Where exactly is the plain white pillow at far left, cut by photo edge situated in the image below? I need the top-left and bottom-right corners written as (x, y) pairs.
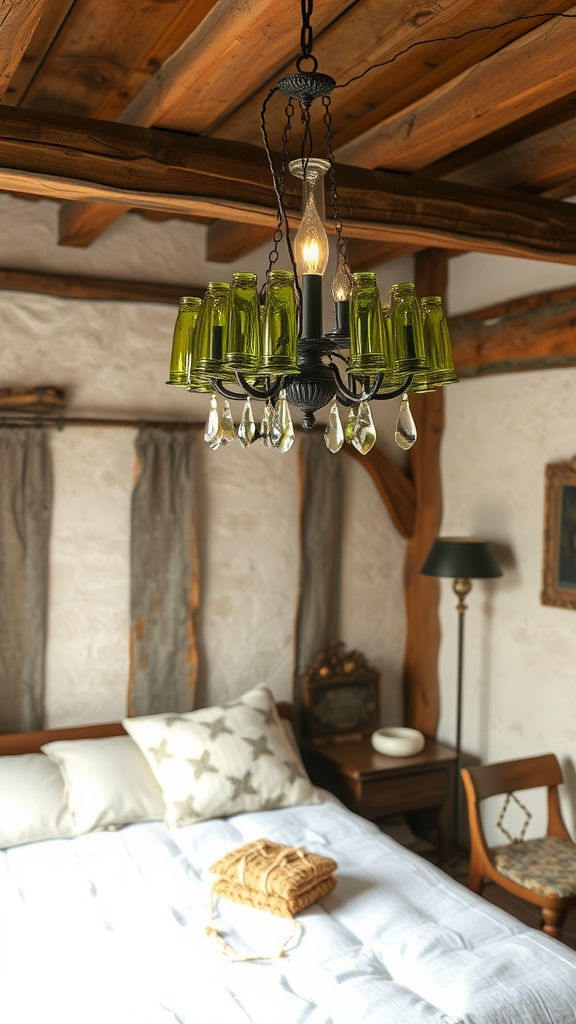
top-left (0, 754), bottom-right (72, 847)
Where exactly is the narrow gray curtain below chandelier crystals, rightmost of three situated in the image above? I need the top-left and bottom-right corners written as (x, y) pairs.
top-left (293, 427), bottom-right (344, 729)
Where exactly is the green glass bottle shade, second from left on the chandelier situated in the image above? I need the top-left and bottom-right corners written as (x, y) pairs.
top-left (191, 281), bottom-right (235, 390)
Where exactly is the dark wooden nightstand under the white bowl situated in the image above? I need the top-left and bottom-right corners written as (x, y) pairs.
top-left (301, 736), bottom-right (456, 863)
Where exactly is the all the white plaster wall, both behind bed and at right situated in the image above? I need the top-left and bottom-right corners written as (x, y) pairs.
top-left (0, 196), bottom-right (576, 843)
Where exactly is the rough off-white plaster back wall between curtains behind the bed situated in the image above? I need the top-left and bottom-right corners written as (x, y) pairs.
top-left (0, 197), bottom-right (404, 725)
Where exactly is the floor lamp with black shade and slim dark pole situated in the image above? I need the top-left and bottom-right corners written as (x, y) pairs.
top-left (420, 537), bottom-right (502, 851)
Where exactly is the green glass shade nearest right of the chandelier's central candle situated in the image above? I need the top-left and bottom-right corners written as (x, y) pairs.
top-left (349, 270), bottom-right (389, 375)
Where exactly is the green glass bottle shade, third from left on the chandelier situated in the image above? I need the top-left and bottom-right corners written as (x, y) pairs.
top-left (224, 273), bottom-right (262, 376)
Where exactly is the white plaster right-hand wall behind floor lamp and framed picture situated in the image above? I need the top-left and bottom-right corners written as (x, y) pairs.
top-left (440, 256), bottom-right (576, 840)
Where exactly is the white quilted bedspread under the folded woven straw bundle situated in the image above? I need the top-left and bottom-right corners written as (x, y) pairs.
top-left (0, 798), bottom-right (576, 1024)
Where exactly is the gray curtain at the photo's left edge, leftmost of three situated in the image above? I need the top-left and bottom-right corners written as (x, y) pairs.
top-left (0, 427), bottom-right (52, 732)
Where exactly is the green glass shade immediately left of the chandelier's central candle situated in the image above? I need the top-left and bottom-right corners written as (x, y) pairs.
top-left (261, 270), bottom-right (299, 377)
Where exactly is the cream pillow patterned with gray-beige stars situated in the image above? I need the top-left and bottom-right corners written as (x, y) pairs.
top-left (122, 686), bottom-right (322, 827)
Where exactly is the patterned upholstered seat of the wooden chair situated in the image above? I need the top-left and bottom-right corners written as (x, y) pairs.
top-left (491, 836), bottom-right (576, 898)
